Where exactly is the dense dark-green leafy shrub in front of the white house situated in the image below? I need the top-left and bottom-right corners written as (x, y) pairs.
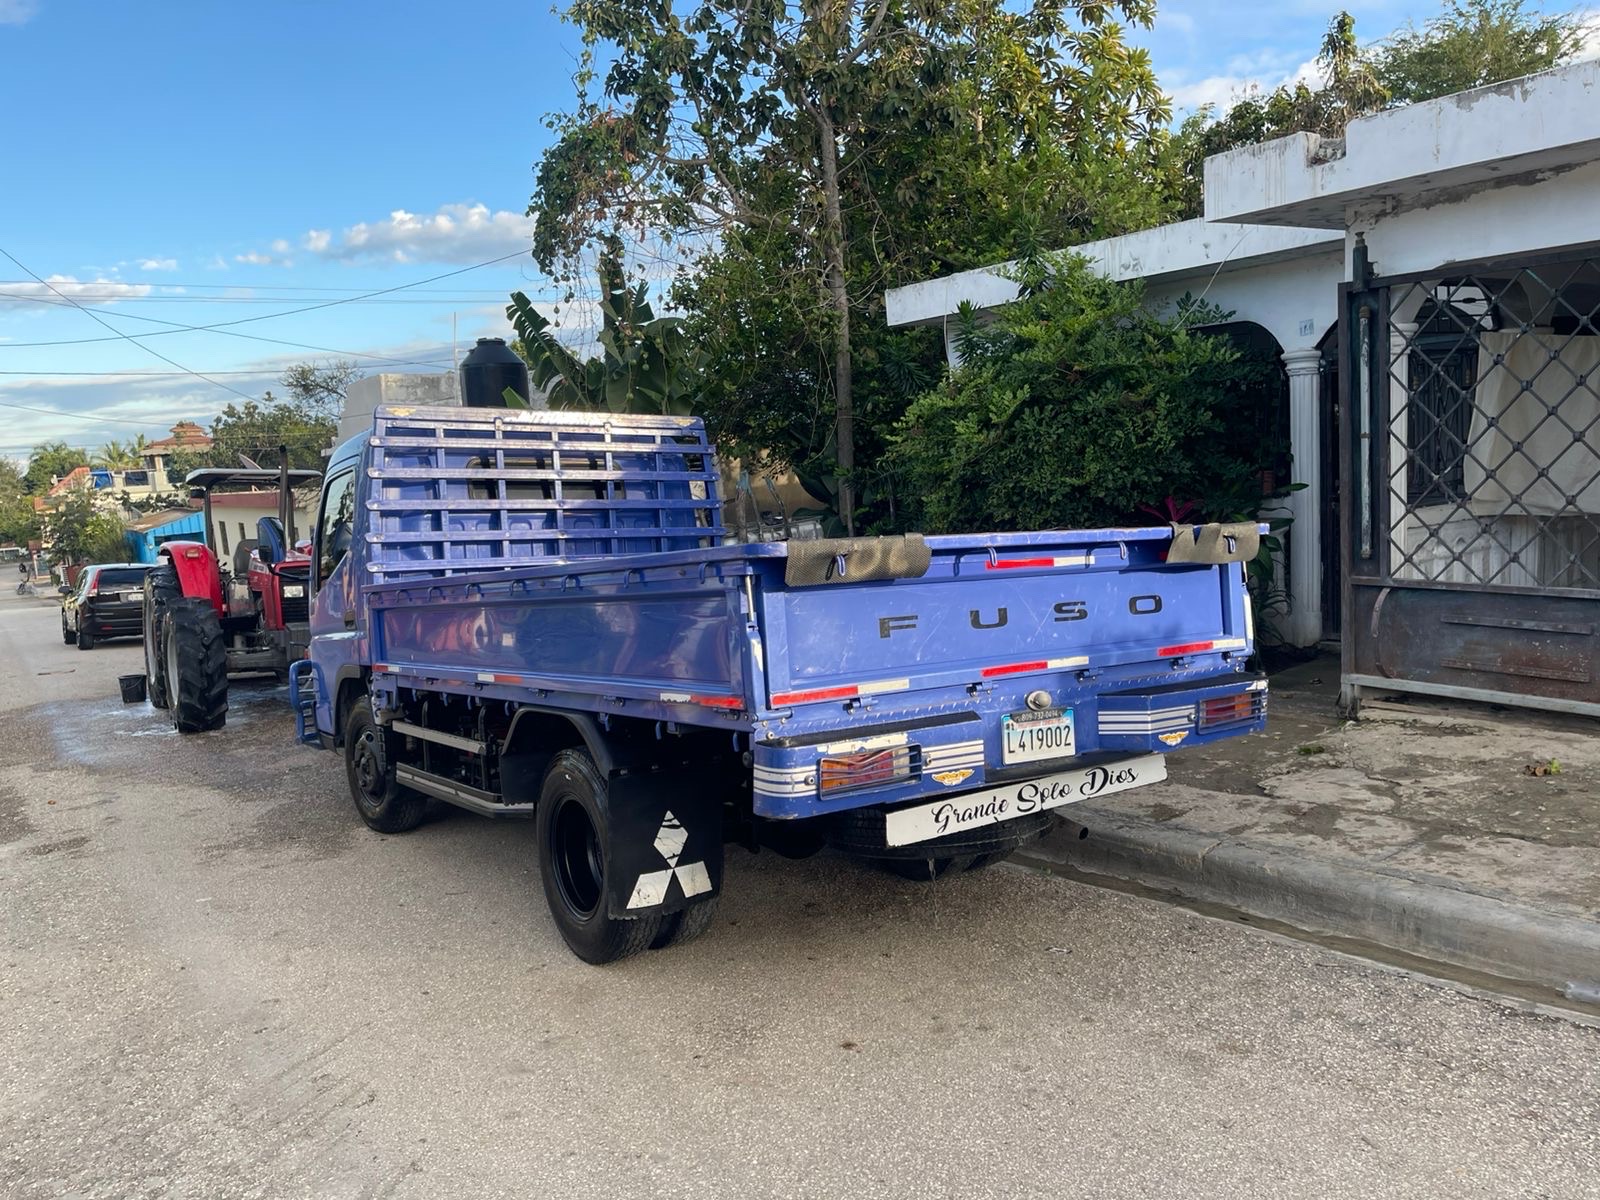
top-left (891, 258), bottom-right (1278, 533)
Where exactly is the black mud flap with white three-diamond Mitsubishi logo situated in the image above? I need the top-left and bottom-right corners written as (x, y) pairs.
top-left (606, 771), bottom-right (722, 917)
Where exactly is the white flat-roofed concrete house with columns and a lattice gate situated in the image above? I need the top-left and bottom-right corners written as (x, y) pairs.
top-left (886, 62), bottom-right (1600, 715)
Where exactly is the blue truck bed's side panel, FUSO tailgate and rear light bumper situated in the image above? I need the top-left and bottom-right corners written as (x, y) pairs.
top-left (365, 528), bottom-right (1266, 818)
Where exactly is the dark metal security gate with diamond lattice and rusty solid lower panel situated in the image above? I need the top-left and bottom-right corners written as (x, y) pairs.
top-left (1339, 246), bottom-right (1600, 717)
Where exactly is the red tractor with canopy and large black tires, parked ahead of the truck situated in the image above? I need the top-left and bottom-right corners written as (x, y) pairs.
top-left (144, 467), bottom-right (322, 733)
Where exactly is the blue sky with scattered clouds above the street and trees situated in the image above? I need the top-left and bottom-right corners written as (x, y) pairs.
top-left (0, 0), bottom-right (1574, 458)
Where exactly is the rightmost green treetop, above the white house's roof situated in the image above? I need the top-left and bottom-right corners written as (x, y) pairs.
top-left (1368, 0), bottom-right (1584, 104)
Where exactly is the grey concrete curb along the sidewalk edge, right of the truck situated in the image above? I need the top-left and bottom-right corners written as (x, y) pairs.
top-left (1011, 806), bottom-right (1600, 1005)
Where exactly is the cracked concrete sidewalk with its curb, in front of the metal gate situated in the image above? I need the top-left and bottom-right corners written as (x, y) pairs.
top-left (1013, 656), bottom-right (1600, 1008)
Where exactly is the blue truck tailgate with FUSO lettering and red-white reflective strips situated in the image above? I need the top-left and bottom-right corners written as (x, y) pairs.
top-left (760, 530), bottom-right (1250, 709)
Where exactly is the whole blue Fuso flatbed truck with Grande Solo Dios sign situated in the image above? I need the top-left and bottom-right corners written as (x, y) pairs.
top-left (291, 400), bottom-right (1267, 963)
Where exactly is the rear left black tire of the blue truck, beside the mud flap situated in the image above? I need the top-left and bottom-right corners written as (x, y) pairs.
top-left (534, 750), bottom-right (662, 966)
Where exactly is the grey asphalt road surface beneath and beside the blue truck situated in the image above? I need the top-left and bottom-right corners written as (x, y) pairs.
top-left (0, 594), bottom-right (1600, 1200)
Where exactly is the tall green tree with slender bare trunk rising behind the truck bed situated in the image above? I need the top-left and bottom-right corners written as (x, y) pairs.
top-left (530, 0), bottom-right (1168, 522)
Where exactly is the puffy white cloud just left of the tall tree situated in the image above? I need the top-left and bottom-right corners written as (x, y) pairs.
top-left (301, 205), bottom-right (533, 262)
